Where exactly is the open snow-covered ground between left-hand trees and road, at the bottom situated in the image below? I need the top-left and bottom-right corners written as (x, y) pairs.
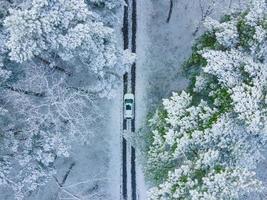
top-left (22, 96), bottom-right (120, 200)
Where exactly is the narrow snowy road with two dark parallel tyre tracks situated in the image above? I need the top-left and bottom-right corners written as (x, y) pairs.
top-left (121, 0), bottom-right (137, 200)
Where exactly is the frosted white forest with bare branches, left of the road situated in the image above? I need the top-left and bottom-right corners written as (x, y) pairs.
top-left (0, 0), bottom-right (125, 199)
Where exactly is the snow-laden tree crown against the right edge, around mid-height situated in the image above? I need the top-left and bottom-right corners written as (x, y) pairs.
top-left (202, 49), bottom-right (267, 132)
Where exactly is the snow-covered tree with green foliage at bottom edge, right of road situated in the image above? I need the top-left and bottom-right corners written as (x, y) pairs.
top-left (148, 161), bottom-right (262, 200)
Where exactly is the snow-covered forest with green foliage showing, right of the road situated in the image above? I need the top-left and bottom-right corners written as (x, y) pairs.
top-left (145, 0), bottom-right (267, 200)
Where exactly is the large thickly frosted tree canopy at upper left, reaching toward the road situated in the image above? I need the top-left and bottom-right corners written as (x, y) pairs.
top-left (5, 0), bottom-right (124, 96)
